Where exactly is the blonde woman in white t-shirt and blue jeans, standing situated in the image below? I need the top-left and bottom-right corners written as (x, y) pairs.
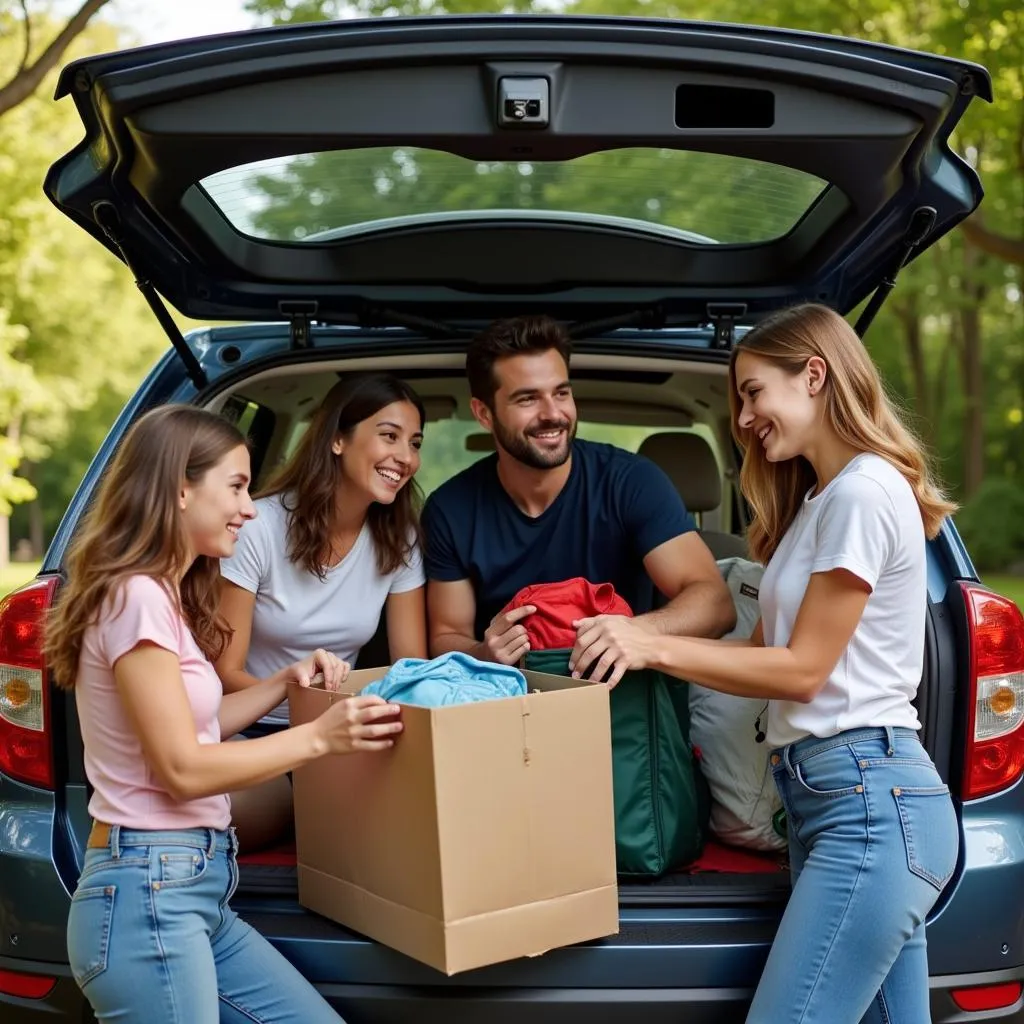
top-left (572, 304), bottom-right (959, 1024)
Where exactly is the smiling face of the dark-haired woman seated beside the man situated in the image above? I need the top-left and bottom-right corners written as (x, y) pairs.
top-left (332, 401), bottom-right (423, 505)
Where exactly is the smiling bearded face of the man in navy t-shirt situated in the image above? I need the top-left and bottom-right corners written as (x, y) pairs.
top-left (473, 348), bottom-right (577, 469)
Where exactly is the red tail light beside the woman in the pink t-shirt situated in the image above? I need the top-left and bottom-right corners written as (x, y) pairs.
top-left (0, 577), bottom-right (57, 790)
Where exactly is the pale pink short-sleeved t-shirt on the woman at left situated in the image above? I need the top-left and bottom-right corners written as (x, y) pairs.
top-left (75, 575), bottom-right (231, 828)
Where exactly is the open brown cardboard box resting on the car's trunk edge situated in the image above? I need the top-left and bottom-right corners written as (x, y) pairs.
top-left (290, 669), bottom-right (618, 975)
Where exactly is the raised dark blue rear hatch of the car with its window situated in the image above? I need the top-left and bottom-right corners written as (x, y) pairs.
top-left (45, 15), bottom-right (991, 360)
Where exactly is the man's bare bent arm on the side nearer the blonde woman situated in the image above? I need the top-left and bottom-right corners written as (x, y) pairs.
top-left (637, 530), bottom-right (736, 637)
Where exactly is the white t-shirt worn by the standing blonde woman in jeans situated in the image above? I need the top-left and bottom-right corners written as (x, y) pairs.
top-left (759, 454), bottom-right (928, 746)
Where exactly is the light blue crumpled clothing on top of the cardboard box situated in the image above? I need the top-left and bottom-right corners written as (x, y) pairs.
top-left (362, 650), bottom-right (526, 708)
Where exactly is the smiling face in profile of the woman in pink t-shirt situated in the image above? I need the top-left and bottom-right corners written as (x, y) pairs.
top-left (178, 444), bottom-right (256, 558)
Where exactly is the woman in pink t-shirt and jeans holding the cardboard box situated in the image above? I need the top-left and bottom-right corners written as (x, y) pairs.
top-left (46, 406), bottom-right (401, 1024)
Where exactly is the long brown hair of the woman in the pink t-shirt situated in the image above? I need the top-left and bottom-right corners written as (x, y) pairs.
top-left (45, 406), bottom-right (246, 689)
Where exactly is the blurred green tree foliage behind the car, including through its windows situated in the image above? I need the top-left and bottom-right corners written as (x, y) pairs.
top-left (0, 0), bottom-right (1024, 567)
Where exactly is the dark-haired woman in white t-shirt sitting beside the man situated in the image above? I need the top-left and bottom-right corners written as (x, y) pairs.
top-left (217, 373), bottom-right (427, 849)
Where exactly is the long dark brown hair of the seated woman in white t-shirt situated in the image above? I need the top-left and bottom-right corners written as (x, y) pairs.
top-left (257, 373), bottom-right (426, 580)
